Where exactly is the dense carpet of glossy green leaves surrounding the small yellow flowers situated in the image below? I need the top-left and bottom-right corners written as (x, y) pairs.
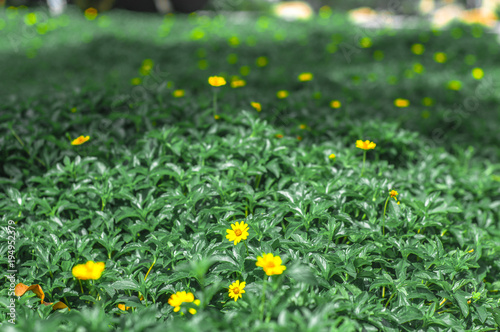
top-left (0, 5), bottom-right (500, 331)
